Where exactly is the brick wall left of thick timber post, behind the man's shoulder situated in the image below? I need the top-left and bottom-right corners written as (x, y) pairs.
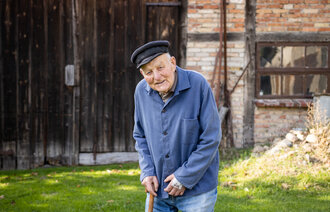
top-left (186, 0), bottom-right (245, 147)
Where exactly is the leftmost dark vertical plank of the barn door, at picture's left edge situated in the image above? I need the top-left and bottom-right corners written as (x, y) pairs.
top-left (0, 0), bottom-right (17, 169)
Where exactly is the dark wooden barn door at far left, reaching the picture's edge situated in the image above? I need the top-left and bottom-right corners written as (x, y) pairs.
top-left (0, 0), bottom-right (73, 169)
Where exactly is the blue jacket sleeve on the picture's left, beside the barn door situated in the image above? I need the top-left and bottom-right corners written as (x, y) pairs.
top-left (133, 94), bottom-right (156, 182)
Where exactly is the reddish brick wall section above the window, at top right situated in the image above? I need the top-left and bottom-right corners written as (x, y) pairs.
top-left (256, 0), bottom-right (330, 32)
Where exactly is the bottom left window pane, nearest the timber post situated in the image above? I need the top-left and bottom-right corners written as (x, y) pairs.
top-left (259, 75), bottom-right (281, 96)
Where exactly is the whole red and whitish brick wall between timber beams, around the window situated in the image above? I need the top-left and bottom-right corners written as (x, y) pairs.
top-left (186, 0), bottom-right (330, 147)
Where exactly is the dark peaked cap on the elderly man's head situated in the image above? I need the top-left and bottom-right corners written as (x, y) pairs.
top-left (131, 40), bottom-right (170, 68)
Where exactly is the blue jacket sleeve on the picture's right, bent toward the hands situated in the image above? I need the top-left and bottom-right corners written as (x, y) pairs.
top-left (174, 85), bottom-right (221, 189)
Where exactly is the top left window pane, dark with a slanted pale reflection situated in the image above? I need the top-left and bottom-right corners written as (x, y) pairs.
top-left (260, 46), bottom-right (281, 68)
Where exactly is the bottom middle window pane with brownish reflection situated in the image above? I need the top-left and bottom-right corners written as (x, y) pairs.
top-left (282, 75), bottom-right (303, 96)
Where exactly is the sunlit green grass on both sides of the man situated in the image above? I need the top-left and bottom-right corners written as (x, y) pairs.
top-left (0, 151), bottom-right (330, 212)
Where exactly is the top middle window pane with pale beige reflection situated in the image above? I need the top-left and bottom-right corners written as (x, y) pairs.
top-left (283, 46), bottom-right (305, 67)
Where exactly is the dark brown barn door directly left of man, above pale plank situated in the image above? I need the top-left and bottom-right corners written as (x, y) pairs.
top-left (77, 0), bottom-right (143, 157)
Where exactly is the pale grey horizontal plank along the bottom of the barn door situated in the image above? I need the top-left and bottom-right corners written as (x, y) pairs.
top-left (79, 152), bottom-right (139, 165)
